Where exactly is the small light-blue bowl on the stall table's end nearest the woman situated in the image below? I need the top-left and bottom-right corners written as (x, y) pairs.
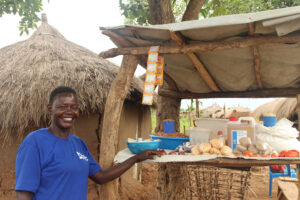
top-left (126, 140), bottom-right (160, 154)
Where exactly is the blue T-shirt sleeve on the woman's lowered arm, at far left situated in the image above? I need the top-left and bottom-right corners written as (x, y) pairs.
top-left (15, 142), bottom-right (41, 193)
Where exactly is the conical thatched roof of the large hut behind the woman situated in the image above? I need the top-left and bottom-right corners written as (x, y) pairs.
top-left (0, 15), bottom-right (143, 139)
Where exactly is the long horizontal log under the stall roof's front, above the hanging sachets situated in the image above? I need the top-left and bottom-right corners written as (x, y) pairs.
top-left (99, 34), bottom-right (300, 58)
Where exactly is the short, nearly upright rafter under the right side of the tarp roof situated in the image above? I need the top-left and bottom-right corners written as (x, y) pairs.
top-left (248, 22), bottom-right (263, 89)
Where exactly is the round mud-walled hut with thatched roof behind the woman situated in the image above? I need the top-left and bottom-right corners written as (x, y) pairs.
top-left (0, 16), bottom-right (151, 200)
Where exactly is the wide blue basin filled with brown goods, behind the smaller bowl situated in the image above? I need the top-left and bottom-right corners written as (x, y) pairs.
top-left (149, 135), bottom-right (190, 150)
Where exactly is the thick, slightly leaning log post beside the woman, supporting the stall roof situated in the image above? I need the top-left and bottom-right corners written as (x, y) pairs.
top-left (100, 56), bottom-right (138, 200)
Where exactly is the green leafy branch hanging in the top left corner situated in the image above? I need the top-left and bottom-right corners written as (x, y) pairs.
top-left (0, 0), bottom-right (43, 35)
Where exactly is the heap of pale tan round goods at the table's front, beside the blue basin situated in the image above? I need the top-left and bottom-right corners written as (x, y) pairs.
top-left (191, 139), bottom-right (234, 156)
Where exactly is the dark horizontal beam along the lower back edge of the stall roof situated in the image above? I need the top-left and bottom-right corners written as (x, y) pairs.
top-left (158, 88), bottom-right (300, 99)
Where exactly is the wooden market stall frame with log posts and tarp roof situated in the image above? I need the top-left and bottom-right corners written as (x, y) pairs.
top-left (100, 7), bottom-right (300, 199)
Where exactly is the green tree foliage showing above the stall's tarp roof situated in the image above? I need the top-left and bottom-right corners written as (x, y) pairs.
top-left (119, 0), bottom-right (300, 25)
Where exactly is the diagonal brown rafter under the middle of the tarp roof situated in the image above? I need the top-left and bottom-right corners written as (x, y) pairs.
top-left (169, 31), bottom-right (220, 92)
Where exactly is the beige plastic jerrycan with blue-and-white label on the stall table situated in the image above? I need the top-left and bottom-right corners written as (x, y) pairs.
top-left (227, 117), bottom-right (255, 149)
